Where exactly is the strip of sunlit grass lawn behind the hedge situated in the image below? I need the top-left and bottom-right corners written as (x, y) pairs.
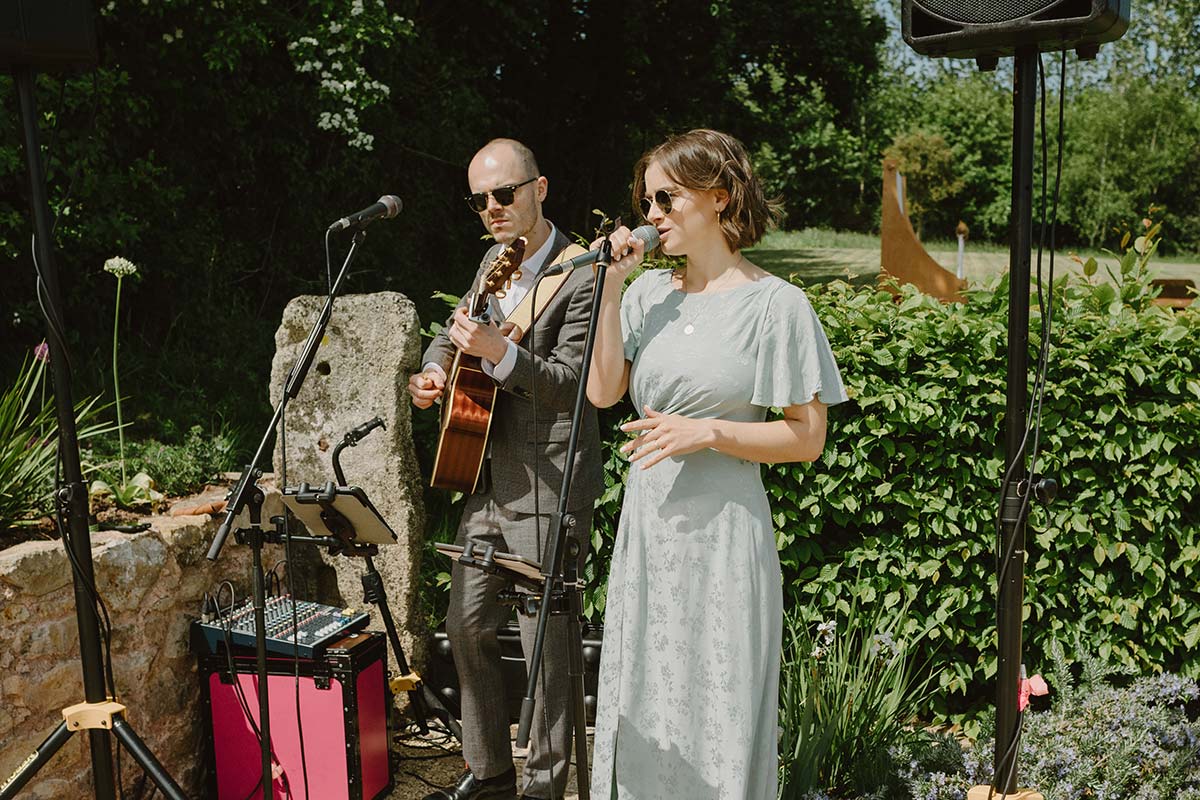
top-left (746, 228), bottom-right (1200, 291)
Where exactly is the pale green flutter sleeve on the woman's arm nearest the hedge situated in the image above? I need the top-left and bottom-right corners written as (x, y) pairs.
top-left (748, 283), bottom-right (848, 408)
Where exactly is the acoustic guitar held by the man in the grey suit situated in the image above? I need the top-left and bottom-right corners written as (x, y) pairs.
top-left (430, 237), bottom-right (526, 492)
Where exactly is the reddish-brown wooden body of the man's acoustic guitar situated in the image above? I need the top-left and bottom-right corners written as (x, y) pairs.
top-left (430, 353), bottom-right (496, 493)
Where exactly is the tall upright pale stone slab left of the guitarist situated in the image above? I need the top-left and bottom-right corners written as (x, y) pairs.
top-left (271, 291), bottom-right (425, 667)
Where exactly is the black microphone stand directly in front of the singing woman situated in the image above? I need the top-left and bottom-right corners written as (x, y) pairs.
top-left (517, 239), bottom-right (612, 800)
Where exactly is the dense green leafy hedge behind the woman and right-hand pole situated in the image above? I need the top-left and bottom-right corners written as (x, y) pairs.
top-left (588, 244), bottom-right (1200, 714)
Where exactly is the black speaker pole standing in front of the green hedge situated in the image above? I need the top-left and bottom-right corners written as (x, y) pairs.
top-left (992, 47), bottom-right (1038, 795)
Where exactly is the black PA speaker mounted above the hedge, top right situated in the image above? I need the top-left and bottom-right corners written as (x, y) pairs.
top-left (900, 0), bottom-right (1129, 60)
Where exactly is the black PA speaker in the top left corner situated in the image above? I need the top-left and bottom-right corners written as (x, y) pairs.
top-left (0, 0), bottom-right (97, 68)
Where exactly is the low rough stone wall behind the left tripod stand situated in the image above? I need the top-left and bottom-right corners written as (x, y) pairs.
top-left (0, 503), bottom-right (282, 800)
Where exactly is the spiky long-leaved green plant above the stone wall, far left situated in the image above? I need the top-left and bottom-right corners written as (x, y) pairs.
top-left (0, 357), bottom-right (114, 531)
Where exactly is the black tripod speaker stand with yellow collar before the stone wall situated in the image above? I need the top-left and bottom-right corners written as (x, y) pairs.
top-left (0, 67), bottom-right (185, 800)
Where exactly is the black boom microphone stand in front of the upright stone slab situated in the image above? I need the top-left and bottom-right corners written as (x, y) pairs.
top-left (206, 228), bottom-right (366, 799)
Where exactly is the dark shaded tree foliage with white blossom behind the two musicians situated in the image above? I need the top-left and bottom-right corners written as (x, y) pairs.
top-left (0, 0), bottom-right (883, 434)
